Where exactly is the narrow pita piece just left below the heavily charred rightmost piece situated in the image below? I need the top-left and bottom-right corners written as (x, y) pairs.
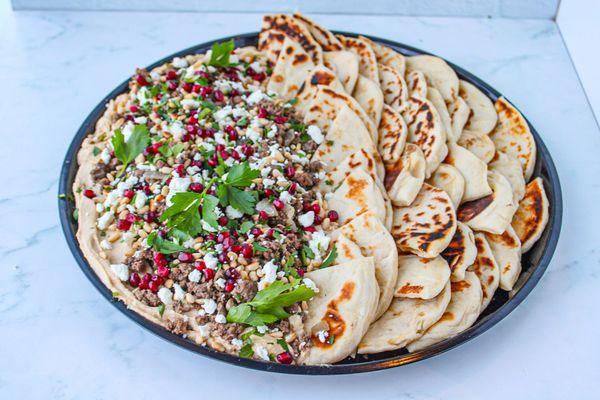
top-left (485, 225), bottom-right (521, 291)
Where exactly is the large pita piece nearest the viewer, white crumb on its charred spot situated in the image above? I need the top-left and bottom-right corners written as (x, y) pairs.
top-left (299, 257), bottom-right (379, 365)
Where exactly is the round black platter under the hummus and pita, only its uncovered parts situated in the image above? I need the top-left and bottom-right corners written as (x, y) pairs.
top-left (59, 32), bottom-right (562, 375)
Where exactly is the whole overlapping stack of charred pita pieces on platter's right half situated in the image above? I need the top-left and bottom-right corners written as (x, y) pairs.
top-left (259, 14), bottom-right (549, 364)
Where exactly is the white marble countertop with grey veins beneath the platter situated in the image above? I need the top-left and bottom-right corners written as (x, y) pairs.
top-left (0, 7), bottom-right (600, 400)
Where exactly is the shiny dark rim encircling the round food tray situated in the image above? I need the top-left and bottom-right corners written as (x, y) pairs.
top-left (58, 31), bottom-right (563, 375)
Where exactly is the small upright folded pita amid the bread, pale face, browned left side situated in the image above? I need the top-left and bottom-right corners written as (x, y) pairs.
top-left (384, 143), bottom-right (426, 207)
